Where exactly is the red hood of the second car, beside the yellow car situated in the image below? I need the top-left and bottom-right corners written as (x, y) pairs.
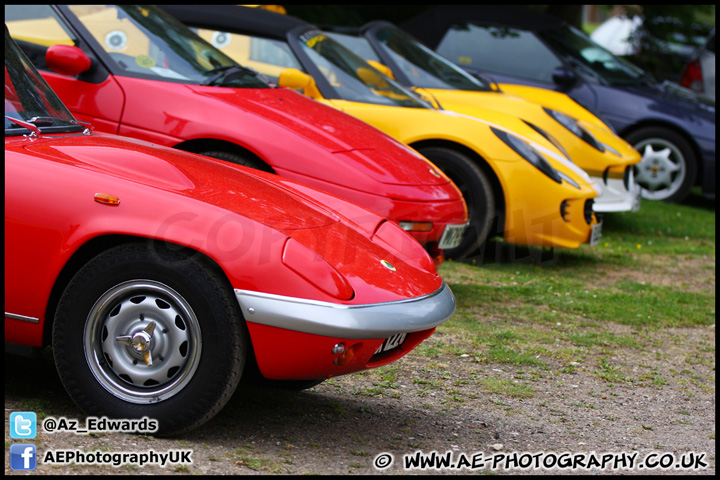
top-left (187, 85), bottom-right (449, 185)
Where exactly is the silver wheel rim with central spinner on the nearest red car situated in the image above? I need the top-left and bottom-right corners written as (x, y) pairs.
top-left (83, 280), bottom-right (202, 404)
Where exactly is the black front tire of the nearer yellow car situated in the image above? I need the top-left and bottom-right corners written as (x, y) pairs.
top-left (419, 147), bottom-right (495, 260)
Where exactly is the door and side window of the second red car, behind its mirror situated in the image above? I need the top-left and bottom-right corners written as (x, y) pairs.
top-left (5, 5), bottom-right (125, 133)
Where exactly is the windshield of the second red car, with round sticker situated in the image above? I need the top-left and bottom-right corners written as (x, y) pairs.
top-left (62, 5), bottom-right (268, 88)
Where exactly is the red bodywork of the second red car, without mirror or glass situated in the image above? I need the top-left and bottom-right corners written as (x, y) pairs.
top-left (43, 67), bottom-right (466, 249)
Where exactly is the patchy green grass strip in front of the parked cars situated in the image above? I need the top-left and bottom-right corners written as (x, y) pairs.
top-left (428, 191), bottom-right (715, 390)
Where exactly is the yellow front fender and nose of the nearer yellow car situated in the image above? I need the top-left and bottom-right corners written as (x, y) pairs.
top-left (320, 99), bottom-right (597, 248)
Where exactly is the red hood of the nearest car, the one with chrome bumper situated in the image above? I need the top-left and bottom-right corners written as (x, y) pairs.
top-left (15, 134), bottom-right (340, 231)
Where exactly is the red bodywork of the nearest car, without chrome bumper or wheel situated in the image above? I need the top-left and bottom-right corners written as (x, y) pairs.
top-left (5, 134), bottom-right (442, 378)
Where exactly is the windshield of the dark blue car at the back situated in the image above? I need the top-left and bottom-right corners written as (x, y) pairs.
top-left (540, 27), bottom-right (646, 85)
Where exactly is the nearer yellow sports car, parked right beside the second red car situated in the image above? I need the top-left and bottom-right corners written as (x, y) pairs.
top-left (166, 5), bottom-right (601, 258)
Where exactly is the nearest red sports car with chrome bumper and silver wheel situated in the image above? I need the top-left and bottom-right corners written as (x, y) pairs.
top-left (5, 29), bottom-right (455, 434)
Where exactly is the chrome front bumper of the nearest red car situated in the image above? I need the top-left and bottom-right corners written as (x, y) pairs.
top-left (235, 282), bottom-right (455, 339)
